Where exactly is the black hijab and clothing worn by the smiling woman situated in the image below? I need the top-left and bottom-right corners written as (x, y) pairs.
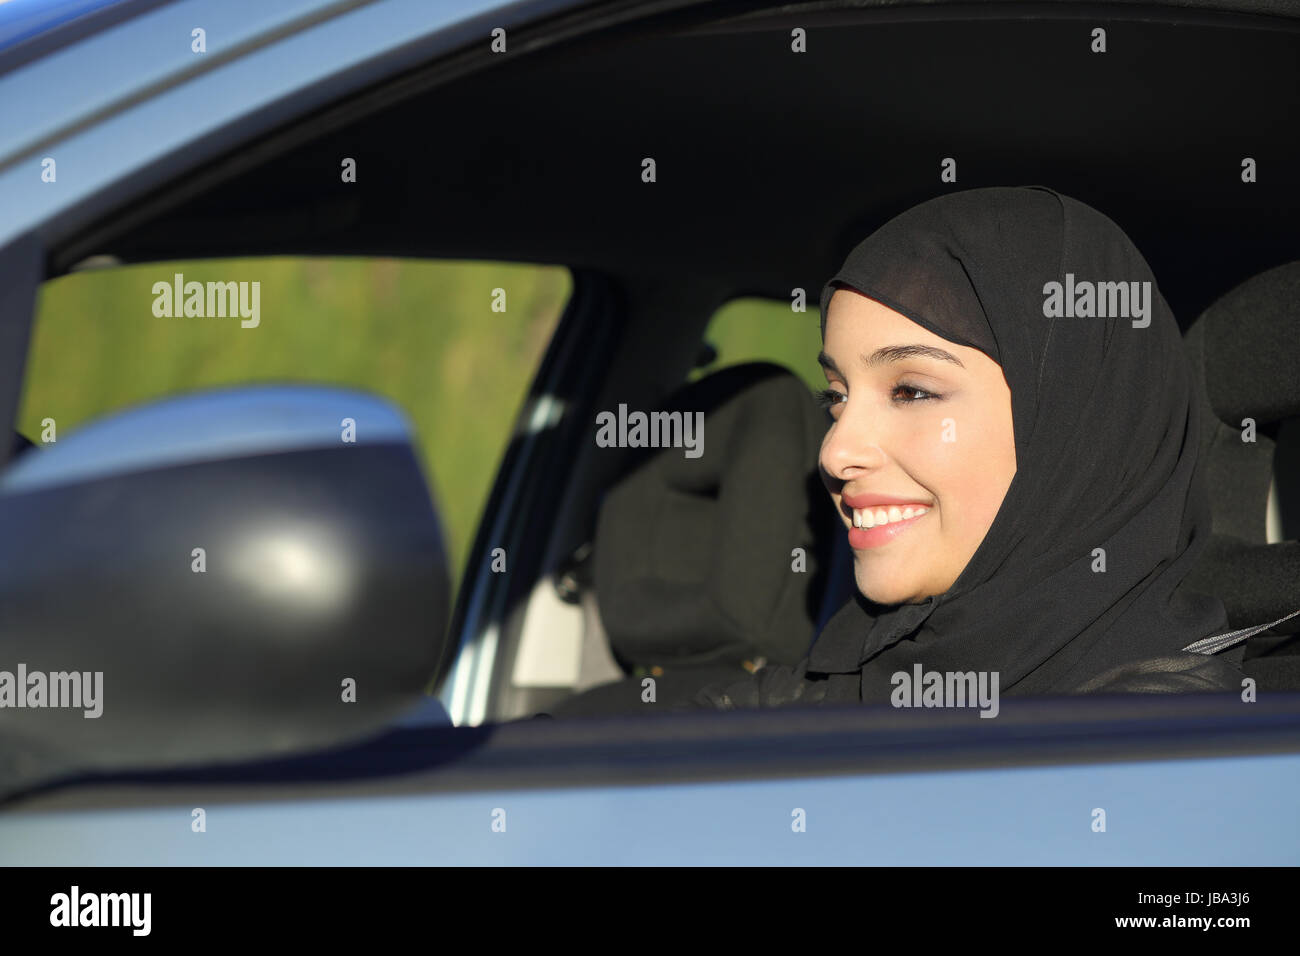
top-left (696, 186), bottom-right (1242, 708)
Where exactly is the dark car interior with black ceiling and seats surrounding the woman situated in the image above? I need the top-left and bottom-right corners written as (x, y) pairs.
top-left (12, 4), bottom-right (1300, 724)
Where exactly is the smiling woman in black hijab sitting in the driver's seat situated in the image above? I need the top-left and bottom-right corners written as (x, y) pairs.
top-left (694, 186), bottom-right (1242, 709)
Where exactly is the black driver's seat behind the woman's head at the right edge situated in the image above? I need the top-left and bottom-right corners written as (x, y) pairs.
top-left (1185, 261), bottom-right (1300, 689)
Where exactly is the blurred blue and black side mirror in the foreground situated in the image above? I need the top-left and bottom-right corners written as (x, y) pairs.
top-left (0, 386), bottom-right (450, 792)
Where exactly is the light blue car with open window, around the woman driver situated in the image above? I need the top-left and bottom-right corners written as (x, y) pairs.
top-left (0, 0), bottom-right (1300, 874)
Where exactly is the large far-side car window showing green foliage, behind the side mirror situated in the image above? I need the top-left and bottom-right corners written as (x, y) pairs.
top-left (18, 258), bottom-right (571, 595)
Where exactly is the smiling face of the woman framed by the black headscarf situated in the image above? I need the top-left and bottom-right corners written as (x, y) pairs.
top-left (820, 289), bottom-right (1015, 604)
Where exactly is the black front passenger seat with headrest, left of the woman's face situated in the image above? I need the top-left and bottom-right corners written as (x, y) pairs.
top-left (593, 363), bottom-right (833, 670)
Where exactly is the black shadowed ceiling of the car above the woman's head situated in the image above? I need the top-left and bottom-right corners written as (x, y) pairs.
top-left (55, 4), bottom-right (1300, 328)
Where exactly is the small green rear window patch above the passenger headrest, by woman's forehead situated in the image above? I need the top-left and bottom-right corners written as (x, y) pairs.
top-left (692, 297), bottom-right (826, 389)
